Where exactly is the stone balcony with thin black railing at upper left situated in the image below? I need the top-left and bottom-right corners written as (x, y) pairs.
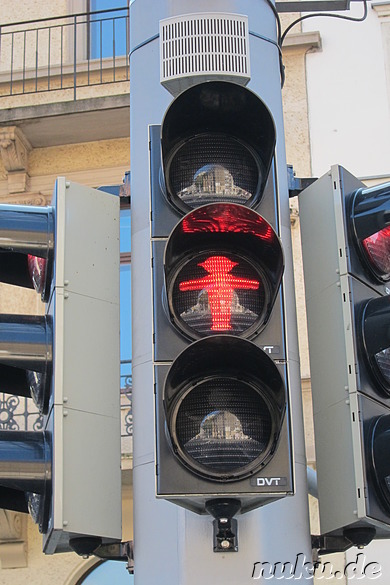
top-left (0, 8), bottom-right (130, 148)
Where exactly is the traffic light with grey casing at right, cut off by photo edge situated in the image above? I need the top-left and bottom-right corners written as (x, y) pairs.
top-left (299, 166), bottom-right (390, 546)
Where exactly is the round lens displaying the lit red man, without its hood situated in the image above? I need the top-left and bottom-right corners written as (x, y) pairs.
top-left (170, 253), bottom-right (267, 336)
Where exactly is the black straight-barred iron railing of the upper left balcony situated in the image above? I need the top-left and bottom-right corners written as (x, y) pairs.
top-left (0, 7), bottom-right (129, 99)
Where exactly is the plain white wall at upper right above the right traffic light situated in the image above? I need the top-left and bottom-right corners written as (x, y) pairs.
top-left (302, 2), bottom-right (390, 177)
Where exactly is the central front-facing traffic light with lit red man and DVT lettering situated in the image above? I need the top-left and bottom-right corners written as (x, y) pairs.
top-left (150, 81), bottom-right (294, 513)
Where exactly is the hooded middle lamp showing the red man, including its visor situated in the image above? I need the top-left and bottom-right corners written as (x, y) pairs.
top-left (164, 203), bottom-right (284, 339)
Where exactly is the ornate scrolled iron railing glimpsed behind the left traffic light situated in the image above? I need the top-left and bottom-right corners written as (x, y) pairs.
top-left (0, 360), bottom-right (133, 438)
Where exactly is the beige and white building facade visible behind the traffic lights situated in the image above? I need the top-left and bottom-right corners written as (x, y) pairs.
top-left (0, 0), bottom-right (390, 585)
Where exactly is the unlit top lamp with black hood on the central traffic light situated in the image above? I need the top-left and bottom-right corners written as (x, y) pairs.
top-left (161, 81), bottom-right (276, 213)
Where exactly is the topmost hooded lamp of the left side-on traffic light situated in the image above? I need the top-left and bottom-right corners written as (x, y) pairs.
top-left (0, 205), bottom-right (54, 302)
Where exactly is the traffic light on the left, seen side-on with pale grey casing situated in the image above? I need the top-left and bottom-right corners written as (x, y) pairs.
top-left (0, 177), bottom-right (121, 554)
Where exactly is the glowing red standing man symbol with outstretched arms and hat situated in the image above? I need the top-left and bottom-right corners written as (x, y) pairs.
top-left (179, 256), bottom-right (260, 331)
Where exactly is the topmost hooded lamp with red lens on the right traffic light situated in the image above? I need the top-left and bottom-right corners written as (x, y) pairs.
top-left (351, 183), bottom-right (390, 282)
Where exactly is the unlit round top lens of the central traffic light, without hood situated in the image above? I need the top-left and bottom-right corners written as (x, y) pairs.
top-left (169, 134), bottom-right (262, 209)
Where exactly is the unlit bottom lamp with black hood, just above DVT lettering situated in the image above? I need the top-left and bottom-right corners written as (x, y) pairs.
top-left (163, 336), bottom-right (286, 482)
